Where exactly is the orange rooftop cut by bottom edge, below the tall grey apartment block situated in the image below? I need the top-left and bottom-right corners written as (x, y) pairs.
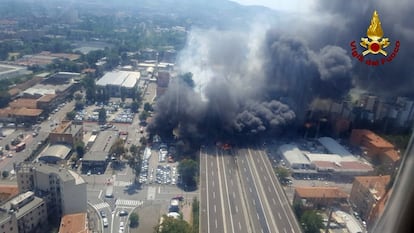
top-left (59, 213), bottom-right (90, 233)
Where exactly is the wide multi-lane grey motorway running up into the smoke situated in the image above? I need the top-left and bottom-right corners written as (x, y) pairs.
top-left (200, 147), bottom-right (301, 233)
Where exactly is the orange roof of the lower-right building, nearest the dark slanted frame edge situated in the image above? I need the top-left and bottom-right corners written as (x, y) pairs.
top-left (354, 175), bottom-right (391, 201)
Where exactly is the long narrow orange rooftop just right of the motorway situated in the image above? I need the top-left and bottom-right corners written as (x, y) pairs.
top-left (295, 187), bottom-right (348, 198)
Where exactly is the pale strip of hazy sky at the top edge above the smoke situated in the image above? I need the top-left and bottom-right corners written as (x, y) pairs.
top-left (232, 0), bottom-right (315, 12)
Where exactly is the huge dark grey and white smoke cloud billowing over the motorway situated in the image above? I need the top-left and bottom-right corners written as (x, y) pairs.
top-left (150, 0), bottom-right (414, 142)
